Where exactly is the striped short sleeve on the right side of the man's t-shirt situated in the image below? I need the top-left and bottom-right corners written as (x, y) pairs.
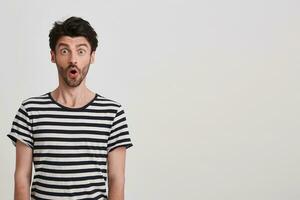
top-left (107, 105), bottom-right (133, 153)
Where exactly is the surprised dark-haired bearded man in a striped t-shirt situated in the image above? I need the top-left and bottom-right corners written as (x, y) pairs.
top-left (7, 17), bottom-right (133, 200)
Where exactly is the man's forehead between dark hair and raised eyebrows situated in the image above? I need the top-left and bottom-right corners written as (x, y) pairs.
top-left (56, 36), bottom-right (91, 48)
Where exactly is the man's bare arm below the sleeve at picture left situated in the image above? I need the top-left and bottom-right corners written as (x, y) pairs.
top-left (14, 141), bottom-right (32, 200)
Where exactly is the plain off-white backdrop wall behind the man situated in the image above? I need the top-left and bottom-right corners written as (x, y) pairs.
top-left (0, 0), bottom-right (300, 200)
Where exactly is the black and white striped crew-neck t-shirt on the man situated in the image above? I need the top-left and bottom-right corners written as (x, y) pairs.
top-left (7, 92), bottom-right (133, 200)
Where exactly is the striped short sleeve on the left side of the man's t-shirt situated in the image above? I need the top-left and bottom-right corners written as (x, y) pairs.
top-left (7, 103), bottom-right (33, 148)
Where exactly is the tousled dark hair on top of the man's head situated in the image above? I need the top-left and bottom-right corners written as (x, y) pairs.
top-left (49, 17), bottom-right (98, 53)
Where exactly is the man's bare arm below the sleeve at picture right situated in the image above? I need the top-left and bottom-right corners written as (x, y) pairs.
top-left (108, 147), bottom-right (126, 200)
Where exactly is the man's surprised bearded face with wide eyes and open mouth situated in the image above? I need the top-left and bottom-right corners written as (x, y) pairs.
top-left (51, 36), bottom-right (95, 87)
